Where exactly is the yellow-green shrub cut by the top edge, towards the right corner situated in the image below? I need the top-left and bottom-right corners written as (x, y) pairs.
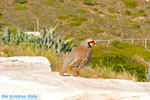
top-left (122, 0), bottom-right (139, 8)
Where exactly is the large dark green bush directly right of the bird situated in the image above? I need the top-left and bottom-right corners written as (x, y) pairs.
top-left (90, 52), bottom-right (147, 81)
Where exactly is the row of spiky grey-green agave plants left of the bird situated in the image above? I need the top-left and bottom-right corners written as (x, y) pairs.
top-left (0, 24), bottom-right (73, 53)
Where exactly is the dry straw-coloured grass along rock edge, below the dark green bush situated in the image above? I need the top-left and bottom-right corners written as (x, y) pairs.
top-left (81, 66), bottom-right (137, 81)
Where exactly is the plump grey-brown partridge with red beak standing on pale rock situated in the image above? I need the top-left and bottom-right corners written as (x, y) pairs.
top-left (59, 39), bottom-right (96, 77)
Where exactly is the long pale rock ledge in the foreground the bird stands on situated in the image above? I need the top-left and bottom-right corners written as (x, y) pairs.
top-left (0, 71), bottom-right (150, 100)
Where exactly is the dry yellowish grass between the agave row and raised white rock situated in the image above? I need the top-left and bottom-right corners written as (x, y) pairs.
top-left (0, 44), bottom-right (64, 71)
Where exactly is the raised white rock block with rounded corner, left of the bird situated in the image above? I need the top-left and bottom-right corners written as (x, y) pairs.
top-left (0, 56), bottom-right (51, 72)
